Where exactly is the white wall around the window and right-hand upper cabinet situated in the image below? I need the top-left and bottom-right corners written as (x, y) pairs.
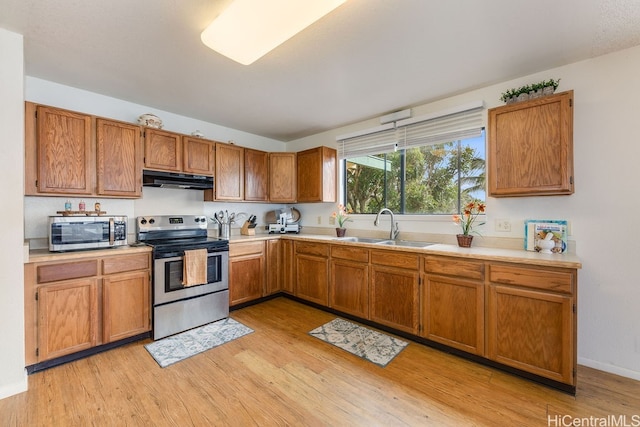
top-left (289, 47), bottom-right (640, 379)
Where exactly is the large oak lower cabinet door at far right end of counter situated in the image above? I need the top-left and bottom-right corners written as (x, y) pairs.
top-left (487, 284), bottom-right (575, 385)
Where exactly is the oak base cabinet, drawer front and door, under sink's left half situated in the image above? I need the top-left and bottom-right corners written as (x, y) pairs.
top-left (329, 245), bottom-right (369, 319)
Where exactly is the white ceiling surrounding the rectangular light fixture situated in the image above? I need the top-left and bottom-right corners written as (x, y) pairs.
top-left (0, 0), bottom-right (640, 141)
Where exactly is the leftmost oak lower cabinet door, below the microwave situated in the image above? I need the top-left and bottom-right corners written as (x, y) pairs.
top-left (38, 279), bottom-right (98, 361)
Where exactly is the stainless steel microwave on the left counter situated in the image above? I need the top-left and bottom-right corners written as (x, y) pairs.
top-left (49, 216), bottom-right (127, 252)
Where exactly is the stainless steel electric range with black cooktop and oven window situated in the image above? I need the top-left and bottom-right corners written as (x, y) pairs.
top-left (136, 215), bottom-right (229, 339)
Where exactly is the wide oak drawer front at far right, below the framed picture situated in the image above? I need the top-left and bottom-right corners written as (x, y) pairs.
top-left (489, 264), bottom-right (574, 294)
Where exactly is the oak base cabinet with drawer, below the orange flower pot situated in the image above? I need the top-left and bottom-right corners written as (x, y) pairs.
top-left (420, 256), bottom-right (484, 356)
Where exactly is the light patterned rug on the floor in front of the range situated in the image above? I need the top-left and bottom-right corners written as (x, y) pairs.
top-left (145, 317), bottom-right (253, 368)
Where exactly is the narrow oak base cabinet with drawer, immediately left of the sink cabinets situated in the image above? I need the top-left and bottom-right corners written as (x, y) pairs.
top-left (294, 242), bottom-right (329, 307)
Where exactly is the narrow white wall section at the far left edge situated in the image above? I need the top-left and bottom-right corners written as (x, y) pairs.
top-left (0, 28), bottom-right (27, 399)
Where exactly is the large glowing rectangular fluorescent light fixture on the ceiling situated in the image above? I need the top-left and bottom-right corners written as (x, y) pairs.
top-left (200, 0), bottom-right (346, 65)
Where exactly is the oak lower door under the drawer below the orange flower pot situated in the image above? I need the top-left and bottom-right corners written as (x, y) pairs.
top-left (421, 275), bottom-right (484, 356)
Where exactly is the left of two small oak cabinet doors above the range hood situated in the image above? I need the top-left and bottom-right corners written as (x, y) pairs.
top-left (144, 128), bottom-right (182, 172)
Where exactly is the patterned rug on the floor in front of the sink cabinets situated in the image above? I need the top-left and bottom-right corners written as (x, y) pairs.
top-left (309, 319), bottom-right (408, 367)
